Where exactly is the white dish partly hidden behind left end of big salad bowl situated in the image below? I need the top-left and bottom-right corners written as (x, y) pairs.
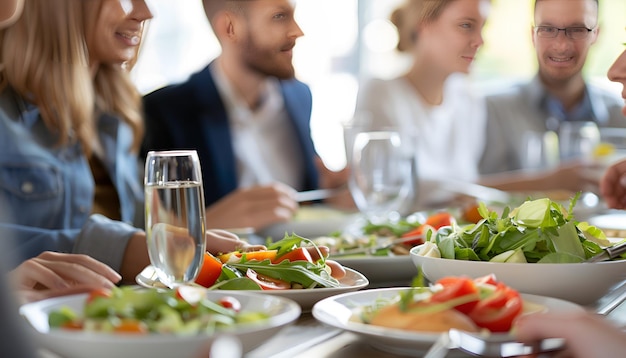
top-left (330, 254), bottom-right (417, 286)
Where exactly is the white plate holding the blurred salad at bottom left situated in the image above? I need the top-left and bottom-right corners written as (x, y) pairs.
top-left (20, 291), bottom-right (301, 358)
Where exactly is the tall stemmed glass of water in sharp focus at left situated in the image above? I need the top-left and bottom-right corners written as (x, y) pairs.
top-left (144, 150), bottom-right (206, 287)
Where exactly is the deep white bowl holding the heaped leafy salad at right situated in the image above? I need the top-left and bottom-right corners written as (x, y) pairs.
top-left (411, 246), bottom-right (626, 305)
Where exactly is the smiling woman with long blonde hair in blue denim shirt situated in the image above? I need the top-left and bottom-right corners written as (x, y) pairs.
top-left (0, 0), bottom-right (260, 288)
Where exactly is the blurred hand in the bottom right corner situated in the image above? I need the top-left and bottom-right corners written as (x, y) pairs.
top-left (513, 312), bottom-right (626, 358)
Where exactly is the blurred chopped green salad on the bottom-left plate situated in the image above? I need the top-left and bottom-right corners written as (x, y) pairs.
top-left (48, 286), bottom-right (269, 335)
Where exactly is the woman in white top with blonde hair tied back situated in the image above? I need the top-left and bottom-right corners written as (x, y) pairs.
top-left (355, 0), bottom-right (490, 205)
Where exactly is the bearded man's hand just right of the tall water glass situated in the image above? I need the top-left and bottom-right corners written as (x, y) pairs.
top-left (206, 183), bottom-right (299, 231)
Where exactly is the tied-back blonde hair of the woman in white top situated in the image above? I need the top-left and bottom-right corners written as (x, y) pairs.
top-left (389, 0), bottom-right (456, 52)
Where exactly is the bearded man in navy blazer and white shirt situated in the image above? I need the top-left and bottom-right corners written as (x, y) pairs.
top-left (143, 0), bottom-right (347, 234)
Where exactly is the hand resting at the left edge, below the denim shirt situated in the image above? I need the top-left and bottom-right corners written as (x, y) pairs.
top-left (9, 251), bottom-right (122, 302)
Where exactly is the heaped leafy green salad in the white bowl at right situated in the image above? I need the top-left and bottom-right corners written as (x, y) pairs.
top-left (418, 194), bottom-right (613, 263)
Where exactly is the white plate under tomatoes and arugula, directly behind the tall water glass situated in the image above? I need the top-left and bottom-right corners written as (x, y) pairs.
top-left (136, 266), bottom-right (369, 311)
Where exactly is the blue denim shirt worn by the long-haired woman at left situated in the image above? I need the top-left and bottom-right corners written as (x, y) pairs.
top-left (0, 89), bottom-right (143, 270)
